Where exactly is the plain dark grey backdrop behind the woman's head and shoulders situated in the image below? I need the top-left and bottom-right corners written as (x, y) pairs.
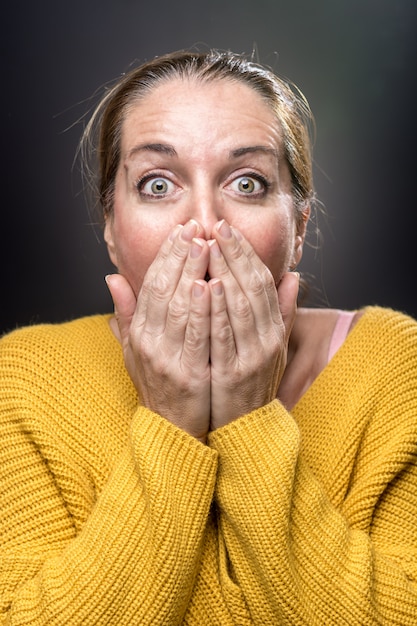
top-left (0, 0), bottom-right (417, 332)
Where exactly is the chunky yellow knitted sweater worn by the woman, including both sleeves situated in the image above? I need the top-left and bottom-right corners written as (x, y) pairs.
top-left (0, 308), bottom-right (417, 626)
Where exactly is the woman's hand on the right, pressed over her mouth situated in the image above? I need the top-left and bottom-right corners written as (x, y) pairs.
top-left (209, 222), bottom-right (299, 430)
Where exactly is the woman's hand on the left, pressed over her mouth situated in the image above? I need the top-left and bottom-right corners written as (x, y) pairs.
top-left (107, 220), bottom-right (210, 442)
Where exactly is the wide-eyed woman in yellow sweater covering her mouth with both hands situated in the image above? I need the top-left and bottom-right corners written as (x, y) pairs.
top-left (0, 52), bottom-right (417, 626)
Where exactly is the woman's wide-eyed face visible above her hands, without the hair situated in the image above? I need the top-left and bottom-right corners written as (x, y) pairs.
top-left (105, 79), bottom-right (305, 294)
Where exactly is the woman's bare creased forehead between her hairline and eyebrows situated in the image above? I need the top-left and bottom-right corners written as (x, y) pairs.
top-left (122, 78), bottom-right (282, 158)
